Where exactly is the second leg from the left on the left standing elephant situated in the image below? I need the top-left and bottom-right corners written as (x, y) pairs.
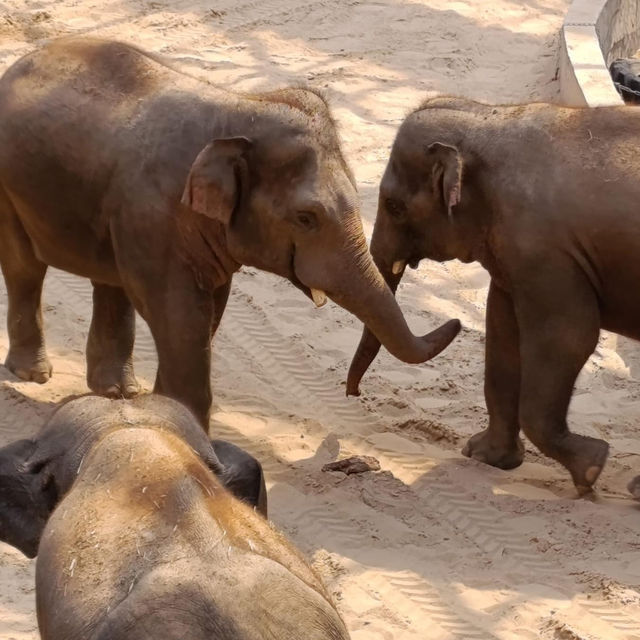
top-left (87, 282), bottom-right (140, 398)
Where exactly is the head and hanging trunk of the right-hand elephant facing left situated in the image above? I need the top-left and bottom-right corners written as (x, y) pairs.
top-left (347, 104), bottom-right (485, 395)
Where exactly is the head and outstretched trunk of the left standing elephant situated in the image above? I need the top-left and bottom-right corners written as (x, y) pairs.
top-left (182, 89), bottom-right (460, 372)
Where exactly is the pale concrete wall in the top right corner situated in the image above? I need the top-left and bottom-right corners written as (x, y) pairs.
top-left (559, 0), bottom-right (640, 107)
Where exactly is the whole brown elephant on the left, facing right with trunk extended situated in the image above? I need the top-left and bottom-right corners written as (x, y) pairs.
top-left (0, 38), bottom-right (459, 425)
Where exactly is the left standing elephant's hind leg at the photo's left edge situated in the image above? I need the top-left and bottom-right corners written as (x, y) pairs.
top-left (0, 189), bottom-right (52, 384)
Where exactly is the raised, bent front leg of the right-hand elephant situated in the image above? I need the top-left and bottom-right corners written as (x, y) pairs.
top-left (515, 263), bottom-right (609, 494)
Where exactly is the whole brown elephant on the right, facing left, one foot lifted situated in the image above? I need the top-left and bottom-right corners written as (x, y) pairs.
top-left (347, 98), bottom-right (640, 493)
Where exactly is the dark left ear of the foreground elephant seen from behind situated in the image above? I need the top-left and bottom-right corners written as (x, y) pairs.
top-left (0, 440), bottom-right (58, 558)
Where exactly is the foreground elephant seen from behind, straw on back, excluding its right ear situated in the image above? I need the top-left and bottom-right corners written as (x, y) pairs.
top-left (0, 396), bottom-right (349, 640)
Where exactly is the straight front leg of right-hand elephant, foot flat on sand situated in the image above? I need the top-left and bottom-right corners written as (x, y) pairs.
top-left (462, 282), bottom-right (524, 469)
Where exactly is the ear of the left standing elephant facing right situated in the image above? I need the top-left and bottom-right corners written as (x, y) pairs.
top-left (181, 137), bottom-right (252, 225)
